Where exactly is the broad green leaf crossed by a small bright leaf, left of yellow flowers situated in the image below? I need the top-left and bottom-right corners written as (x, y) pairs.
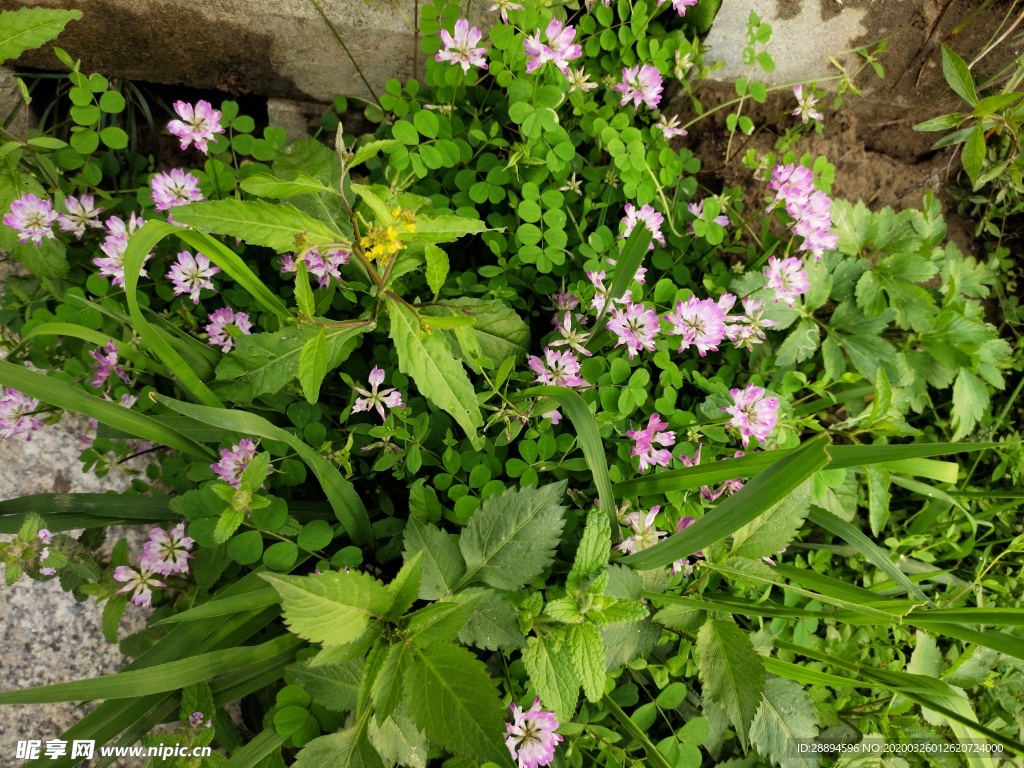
top-left (217, 321), bottom-right (374, 402)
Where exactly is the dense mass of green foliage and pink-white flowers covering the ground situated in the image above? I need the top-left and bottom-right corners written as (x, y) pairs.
top-left (0, 0), bottom-right (1024, 768)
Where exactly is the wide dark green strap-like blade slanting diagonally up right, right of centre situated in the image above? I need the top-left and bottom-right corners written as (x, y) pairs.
top-left (621, 434), bottom-right (828, 570)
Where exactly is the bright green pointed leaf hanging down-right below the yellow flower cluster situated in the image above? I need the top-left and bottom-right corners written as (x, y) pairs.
top-left (388, 300), bottom-right (483, 440)
